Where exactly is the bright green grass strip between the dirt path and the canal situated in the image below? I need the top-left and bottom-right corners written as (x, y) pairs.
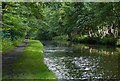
top-left (3, 40), bottom-right (57, 79)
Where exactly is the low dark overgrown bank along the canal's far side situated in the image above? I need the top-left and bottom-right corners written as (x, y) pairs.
top-left (52, 35), bottom-right (120, 47)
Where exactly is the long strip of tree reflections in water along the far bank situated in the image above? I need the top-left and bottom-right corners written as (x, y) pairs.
top-left (54, 42), bottom-right (119, 55)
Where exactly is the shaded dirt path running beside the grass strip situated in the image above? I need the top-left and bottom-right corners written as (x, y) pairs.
top-left (2, 41), bottom-right (29, 76)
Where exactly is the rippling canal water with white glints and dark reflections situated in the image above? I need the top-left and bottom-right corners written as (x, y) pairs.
top-left (43, 41), bottom-right (120, 80)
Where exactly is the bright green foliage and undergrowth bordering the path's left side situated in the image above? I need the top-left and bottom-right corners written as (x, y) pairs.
top-left (0, 2), bottom-right (43, 52)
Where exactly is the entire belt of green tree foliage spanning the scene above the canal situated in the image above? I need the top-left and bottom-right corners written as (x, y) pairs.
top-left (0, 2), bottom-right (120, 48)
